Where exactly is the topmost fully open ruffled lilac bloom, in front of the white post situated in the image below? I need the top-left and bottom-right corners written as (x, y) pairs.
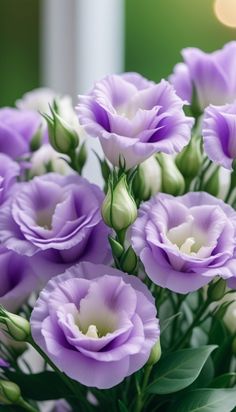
top-left (77, 73), bottom-right (193, 169)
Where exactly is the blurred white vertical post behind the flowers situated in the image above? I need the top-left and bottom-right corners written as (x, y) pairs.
top-left (41, 0), bottom-right (124, 183)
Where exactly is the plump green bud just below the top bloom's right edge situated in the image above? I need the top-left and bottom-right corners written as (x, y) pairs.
top-left (175, 136), bottom-right (202, 179)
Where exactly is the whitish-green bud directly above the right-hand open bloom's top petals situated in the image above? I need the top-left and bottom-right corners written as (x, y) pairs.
top-left (157, 153), bottom-right (185, 196)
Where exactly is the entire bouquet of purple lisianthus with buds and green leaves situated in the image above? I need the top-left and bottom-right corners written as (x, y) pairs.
top-left (0, 42), bottom-right (236, 412)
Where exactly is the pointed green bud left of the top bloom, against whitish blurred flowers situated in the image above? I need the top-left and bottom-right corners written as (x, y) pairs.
top-left (43, 108), bottom-right (79, 154)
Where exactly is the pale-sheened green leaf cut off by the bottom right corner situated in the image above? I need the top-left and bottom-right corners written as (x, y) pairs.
top-left (169, 389), bottom-right (236, 412)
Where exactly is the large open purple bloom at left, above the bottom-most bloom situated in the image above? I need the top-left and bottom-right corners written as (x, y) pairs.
top-left (0, 173), bottom-right (109, 278)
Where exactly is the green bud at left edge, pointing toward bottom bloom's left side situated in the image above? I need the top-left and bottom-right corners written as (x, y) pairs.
top-left (0, 308), bottom-right (30, 342)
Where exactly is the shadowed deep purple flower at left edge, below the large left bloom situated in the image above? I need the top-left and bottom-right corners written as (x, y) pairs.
top-left (0, 246), bottom-right (37, 312)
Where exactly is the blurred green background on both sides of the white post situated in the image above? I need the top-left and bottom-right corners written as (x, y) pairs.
top-left (0, 0), bottom-right (236, 106)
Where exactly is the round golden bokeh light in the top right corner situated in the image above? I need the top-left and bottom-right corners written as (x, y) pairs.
top-left (214, 0), bottom-right (236, 28)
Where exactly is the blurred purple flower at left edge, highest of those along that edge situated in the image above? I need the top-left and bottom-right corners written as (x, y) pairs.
top-left (0, 108), bottom-right (42, 159)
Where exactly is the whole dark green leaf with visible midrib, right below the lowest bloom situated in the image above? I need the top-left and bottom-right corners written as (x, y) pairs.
top-left (147, 345), bottom-right (216, 395)
